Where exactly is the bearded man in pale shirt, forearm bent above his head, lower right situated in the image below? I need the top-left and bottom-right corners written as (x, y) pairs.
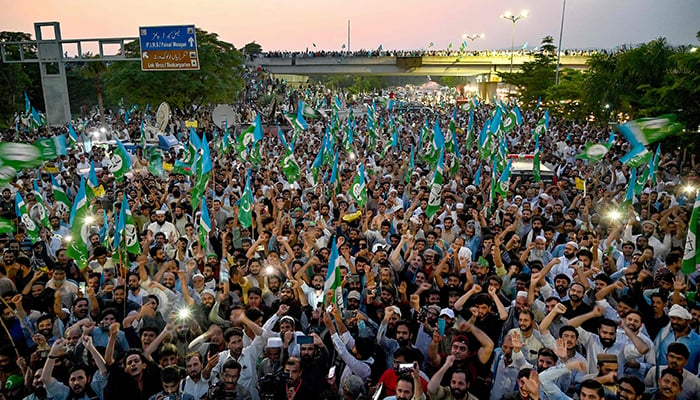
top-left (569, 306), bottom-right (649, 376)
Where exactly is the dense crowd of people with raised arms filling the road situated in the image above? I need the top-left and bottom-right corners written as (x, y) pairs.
top-left (0, 68), bottom-right (700, 400)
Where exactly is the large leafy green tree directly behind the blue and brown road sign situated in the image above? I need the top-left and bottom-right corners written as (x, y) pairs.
top-left (105, 29), bottom-right (244, 107)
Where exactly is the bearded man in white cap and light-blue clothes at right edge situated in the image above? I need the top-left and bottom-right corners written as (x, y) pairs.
top-left (654, 304), bottom-right (700, 374)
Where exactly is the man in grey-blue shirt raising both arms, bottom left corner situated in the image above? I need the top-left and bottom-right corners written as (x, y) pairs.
top-left (41, 336), bottom-right (109, 400)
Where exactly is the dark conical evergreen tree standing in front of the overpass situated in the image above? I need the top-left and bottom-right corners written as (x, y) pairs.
top-left (498, 36), bottom-right (557, 104)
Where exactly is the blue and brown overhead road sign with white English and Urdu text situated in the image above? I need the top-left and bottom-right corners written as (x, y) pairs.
top-left (139, 25), bottom-right (199, 71)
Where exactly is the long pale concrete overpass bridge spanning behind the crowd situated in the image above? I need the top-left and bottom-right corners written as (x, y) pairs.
top-left (248, 54), bottom-right (588, 76)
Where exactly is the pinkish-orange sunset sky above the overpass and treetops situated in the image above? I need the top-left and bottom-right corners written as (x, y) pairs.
top-left (0, 0), bottom-right (700, 50)
